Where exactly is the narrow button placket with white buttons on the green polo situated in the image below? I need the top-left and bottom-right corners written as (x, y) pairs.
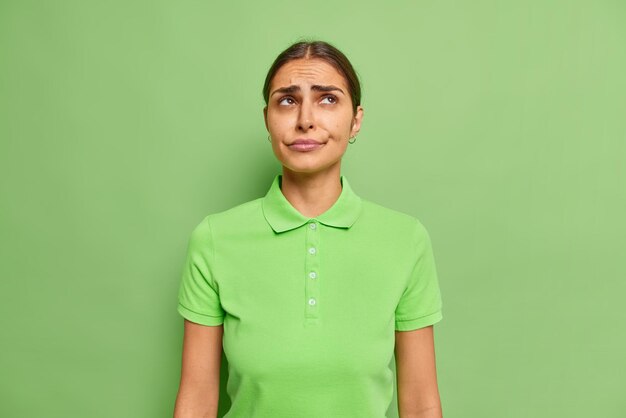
top-left (304, 219), bottom-right (320, 319)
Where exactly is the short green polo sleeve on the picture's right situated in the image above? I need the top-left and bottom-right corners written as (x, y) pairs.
top-left (395, 221), bottom-right (443, 331)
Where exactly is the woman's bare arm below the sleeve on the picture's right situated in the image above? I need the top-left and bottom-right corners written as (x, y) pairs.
top-left (395, 325), bottom-right (443, 418)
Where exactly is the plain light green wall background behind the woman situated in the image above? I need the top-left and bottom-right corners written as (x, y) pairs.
top-left (0, 0), bottom-right (626, 418)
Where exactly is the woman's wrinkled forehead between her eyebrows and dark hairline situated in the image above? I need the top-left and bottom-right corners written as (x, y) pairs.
top-left (272, 58), bottom-right (346, 88)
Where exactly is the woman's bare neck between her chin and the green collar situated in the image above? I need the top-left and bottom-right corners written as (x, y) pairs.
top-left (281, 165), bottom-right (341, 218)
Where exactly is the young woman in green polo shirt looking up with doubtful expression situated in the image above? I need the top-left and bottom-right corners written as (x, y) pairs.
top-left (174, 42), bottom-right (442, 418)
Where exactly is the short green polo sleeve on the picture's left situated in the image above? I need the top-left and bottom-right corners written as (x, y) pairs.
top-left (178, 216), bottom-right (224, 325)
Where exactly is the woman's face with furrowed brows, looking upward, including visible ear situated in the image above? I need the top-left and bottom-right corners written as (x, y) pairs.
top-left (263, 59), bottom-right (363, 174)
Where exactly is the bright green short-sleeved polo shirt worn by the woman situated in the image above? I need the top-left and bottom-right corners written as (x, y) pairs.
top-left (178, 174), bottom-right (442, 418)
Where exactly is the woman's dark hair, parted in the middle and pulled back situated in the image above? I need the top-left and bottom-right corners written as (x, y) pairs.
top-left (263, 41), bottom-right (361, 114)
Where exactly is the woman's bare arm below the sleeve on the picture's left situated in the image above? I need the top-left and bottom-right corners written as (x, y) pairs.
top-left (174, 319), bottom-right (224, 418)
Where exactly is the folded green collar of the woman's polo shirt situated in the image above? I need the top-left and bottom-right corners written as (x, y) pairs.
top-left (263, 174), bottom-right (361, 232)
